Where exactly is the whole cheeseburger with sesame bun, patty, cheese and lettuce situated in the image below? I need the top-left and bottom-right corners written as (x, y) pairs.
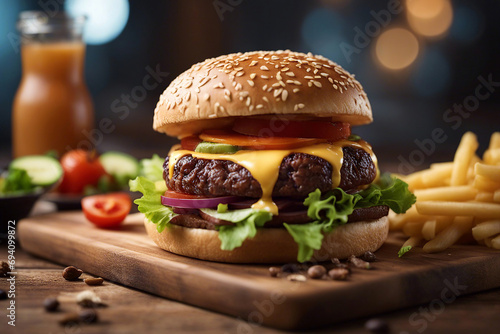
top-left (131, 50), bottom-right (415, 263)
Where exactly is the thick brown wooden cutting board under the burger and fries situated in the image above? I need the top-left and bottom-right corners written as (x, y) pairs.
top-left (18, 212), bottom-right (500, 333)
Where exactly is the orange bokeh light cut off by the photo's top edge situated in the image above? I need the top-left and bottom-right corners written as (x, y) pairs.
top-left (406, 0), bottom-right (453, 38)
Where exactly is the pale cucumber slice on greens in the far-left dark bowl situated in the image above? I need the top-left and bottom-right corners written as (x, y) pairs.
top-left (9, 155), bottom-right (63, 187)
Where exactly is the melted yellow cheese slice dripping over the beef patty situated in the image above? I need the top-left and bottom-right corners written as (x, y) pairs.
top-left (168, 140), bottom-right (378, 215)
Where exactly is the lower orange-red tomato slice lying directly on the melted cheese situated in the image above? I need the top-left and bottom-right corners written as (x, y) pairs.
top-left (200, 130), bottom-right (325, 150)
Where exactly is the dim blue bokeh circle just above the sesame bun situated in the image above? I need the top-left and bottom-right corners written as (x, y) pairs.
top-left (301, 8), bottom-right (348, 66)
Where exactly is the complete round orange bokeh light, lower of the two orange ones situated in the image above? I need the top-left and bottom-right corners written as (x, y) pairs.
top-left (375, 28), bottom-right (419, 70)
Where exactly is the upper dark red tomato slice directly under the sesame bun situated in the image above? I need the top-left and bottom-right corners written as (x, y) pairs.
top-left (233, 118), bottom-right (351, 141)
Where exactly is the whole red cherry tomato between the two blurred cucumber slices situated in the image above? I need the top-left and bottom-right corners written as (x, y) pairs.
top-left (59, 150), bottom-right (106, 194)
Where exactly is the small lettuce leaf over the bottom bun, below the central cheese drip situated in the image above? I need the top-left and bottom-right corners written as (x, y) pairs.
top-left (200, 209), bottom-right (272, 250)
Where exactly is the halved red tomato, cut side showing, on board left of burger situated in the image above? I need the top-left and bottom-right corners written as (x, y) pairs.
top-left (82, 193), bottom-right (132, 228)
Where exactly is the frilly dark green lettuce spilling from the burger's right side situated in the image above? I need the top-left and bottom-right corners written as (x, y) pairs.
top-left (284, 176), bottom-right (416, 262)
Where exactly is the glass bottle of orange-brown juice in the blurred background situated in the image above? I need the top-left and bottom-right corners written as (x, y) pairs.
top-left (12, 11), bottom-right (94, 157)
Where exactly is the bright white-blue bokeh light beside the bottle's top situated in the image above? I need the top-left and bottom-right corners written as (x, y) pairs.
top-left (65, 0), bottom-right (130, 44)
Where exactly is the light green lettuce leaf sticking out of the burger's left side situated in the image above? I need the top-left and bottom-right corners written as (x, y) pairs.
top-left (129, 176), bottom-right (176, 233)
